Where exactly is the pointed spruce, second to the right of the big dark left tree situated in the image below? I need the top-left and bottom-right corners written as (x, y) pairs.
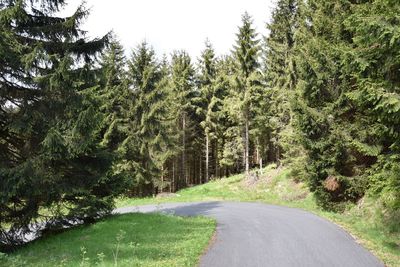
top-left (128, 42), bottom-right (171, 195)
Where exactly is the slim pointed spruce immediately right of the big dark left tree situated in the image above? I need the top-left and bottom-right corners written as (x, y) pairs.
top-left (93, 37), bottom-right (133, 195)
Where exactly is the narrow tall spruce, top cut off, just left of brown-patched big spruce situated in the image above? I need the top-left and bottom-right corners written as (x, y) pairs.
top-left (264, 0), bottom-right (298, 162)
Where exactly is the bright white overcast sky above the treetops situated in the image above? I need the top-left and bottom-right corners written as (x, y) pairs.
top-left (63, 0), bottom-right (275, 58)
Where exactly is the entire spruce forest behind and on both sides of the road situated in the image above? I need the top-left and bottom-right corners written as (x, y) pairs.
top-left (0, 0), bottom-right (400, 250)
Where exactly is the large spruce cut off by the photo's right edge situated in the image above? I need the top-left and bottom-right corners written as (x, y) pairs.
top-left (343, 0), bottom-right (400, 214)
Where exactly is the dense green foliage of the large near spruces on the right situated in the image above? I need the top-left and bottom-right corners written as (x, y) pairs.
top-left (291, 0), bottom-right (400, 214)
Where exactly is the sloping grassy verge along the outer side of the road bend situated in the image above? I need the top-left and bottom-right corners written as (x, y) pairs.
top-left (117, 165), bottom-right (400, 267)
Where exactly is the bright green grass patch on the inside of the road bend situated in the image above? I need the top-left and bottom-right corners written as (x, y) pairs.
top-left (0, 213), bottom-right (216, 266)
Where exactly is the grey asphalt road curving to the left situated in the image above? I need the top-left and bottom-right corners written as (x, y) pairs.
top-left (116, 202), bottom-right (383, 267)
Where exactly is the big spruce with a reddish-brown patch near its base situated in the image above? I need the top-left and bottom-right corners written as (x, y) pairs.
top-left (294, 0), bottom-right (369, 209)
